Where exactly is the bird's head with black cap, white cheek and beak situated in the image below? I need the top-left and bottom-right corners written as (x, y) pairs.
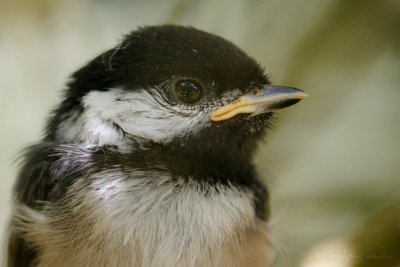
top-left (45, 26), bottom-right (306, 174)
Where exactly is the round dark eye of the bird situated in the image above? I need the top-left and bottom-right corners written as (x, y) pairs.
top-left (174, 79), bottom-right (203, 104)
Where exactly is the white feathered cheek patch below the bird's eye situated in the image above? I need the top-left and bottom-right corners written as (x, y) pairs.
top-left (57, 89), bottom-right (210, 145)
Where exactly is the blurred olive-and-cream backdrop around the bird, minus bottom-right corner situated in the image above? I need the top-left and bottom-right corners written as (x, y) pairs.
top-left (0, 0), bottom-right (400, 267)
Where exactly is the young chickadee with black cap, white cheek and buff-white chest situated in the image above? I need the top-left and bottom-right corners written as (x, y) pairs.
top-left (7, 25), bottom-right (307, 267)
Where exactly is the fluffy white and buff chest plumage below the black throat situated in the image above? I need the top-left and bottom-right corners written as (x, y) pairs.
top-left (14, 172), bottom-right (270, 267)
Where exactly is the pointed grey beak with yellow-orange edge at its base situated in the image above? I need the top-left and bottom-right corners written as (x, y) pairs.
top-left (211, 84), bottom-right (308, 121)
